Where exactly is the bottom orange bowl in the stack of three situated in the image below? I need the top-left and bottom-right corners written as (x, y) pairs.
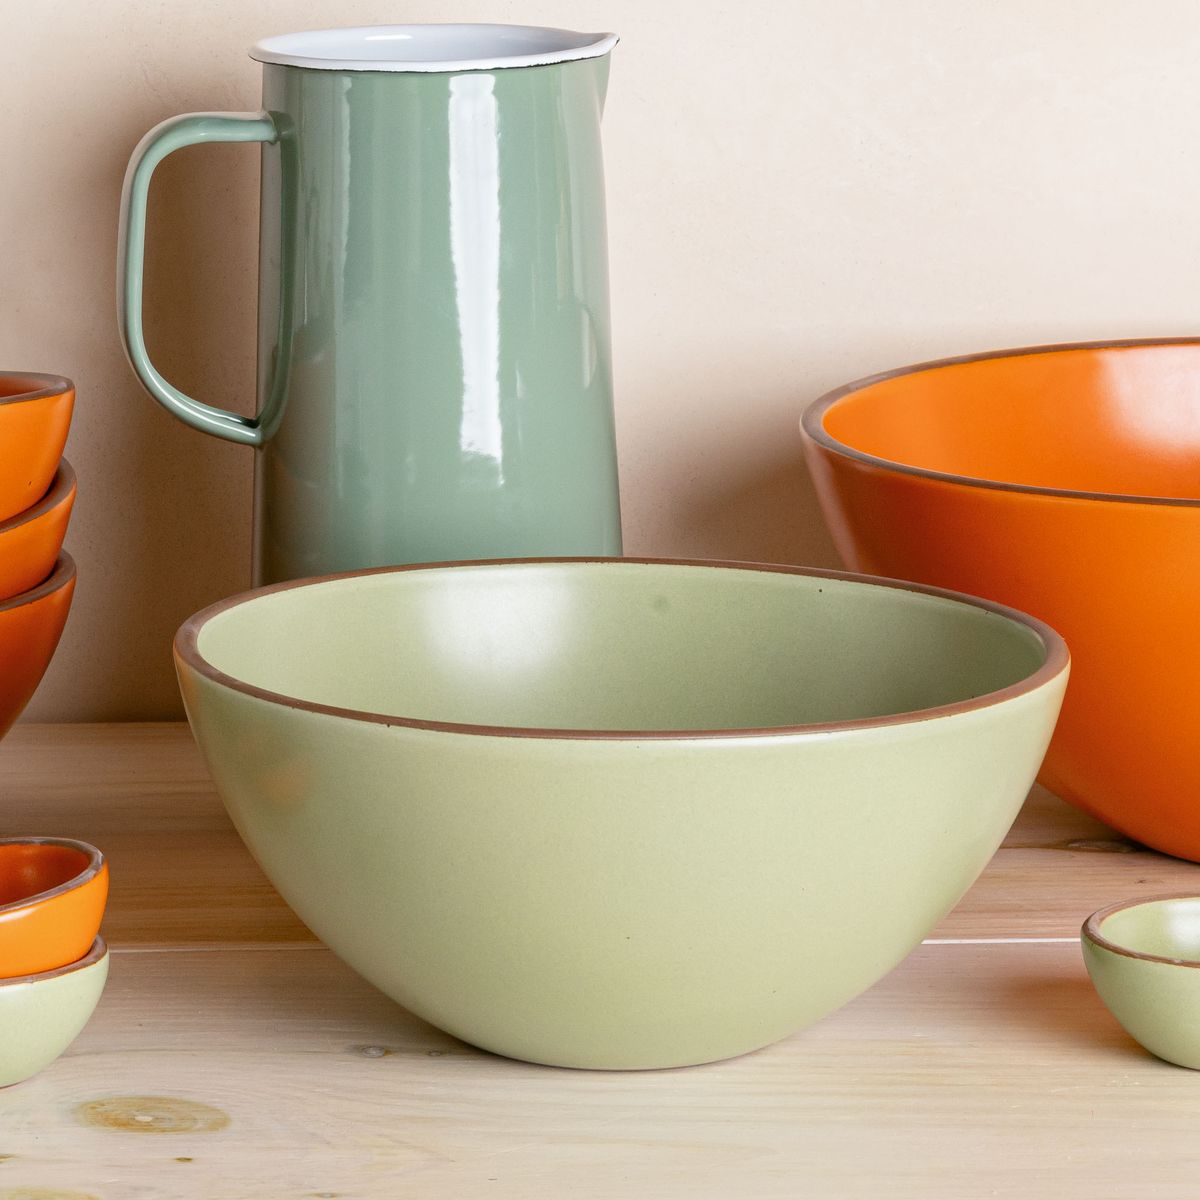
top-left (0, 554), bottom-right (76, 738)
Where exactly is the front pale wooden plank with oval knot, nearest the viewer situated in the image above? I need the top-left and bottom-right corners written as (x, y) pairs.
top-left (0, 943), bottom-right (1200, 1200)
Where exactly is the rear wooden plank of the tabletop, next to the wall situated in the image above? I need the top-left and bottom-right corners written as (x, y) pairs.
top-left (0, 725), bottom-right (1200, 945)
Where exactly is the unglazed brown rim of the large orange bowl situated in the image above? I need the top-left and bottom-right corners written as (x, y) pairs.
top-left (800, 337), bottom-right (1200, 508)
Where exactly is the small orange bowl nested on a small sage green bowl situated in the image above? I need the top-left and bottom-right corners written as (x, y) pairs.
top-left (0, 838), bottom-right (108, 979)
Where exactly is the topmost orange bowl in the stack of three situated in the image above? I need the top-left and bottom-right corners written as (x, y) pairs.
top-left (0, 372), bottom-right (74, 521)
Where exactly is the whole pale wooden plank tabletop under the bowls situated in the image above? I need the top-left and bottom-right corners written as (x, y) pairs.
top-left (0, 726), bottom-right (1200, 1200)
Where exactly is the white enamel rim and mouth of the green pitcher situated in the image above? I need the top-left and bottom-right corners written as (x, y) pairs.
top-left (250, 24), bottom-right (617, 73)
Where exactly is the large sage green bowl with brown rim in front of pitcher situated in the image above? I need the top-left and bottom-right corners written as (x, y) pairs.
top-left (175, 559), bottom-right (1068, 1068)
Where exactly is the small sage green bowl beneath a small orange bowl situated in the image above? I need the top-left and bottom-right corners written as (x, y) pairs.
top-left (0, 937), bottom-right (108, 1087)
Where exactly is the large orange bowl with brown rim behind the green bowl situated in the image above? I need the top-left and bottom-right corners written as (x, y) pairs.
top-left (802, 340), bottom-right (1200, 860)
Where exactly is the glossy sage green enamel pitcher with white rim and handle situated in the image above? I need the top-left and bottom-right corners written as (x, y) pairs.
top-left (118, 25), bottom-right (620, 582)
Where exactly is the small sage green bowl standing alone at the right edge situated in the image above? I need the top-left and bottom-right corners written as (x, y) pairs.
top-left (1081, 895), bottom-right (1200, 1070)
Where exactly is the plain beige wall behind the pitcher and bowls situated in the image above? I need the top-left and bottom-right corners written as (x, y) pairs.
top-left (0, 0), bottom-right (1200, 720)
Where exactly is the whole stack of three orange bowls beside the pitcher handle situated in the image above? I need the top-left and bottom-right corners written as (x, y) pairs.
top-left (0, 372), bottom-right (76, 737)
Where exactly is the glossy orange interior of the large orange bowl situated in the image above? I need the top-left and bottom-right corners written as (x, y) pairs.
top-left (822, 342), bottom-right (1200, 499)
